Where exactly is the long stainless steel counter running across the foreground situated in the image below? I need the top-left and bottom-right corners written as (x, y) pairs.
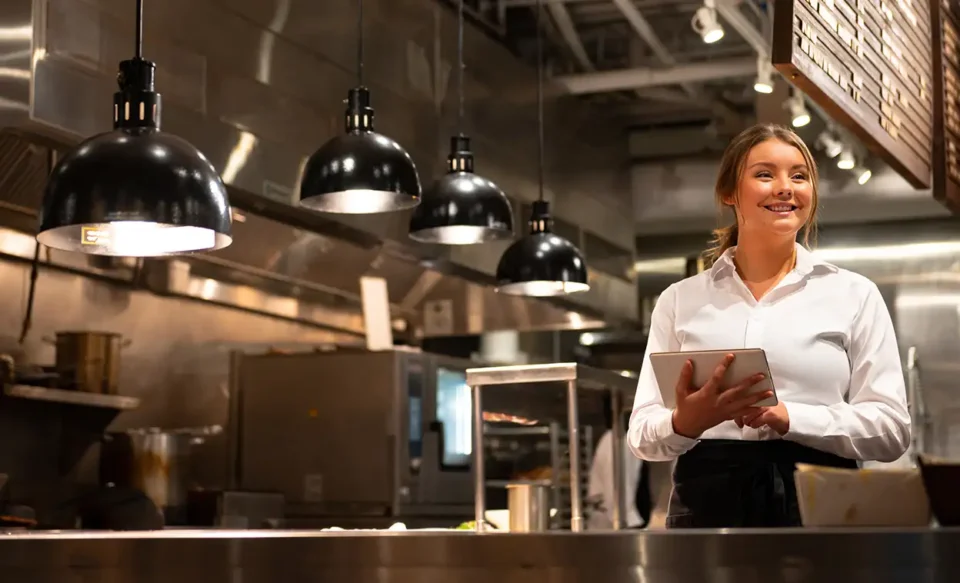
top-left (0, 529), bottom-right (960, 583)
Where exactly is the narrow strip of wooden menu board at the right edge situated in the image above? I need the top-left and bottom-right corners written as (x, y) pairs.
top-left (930, 0), bottom-right (960, 213)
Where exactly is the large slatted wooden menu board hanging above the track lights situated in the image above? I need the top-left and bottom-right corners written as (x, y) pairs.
top-left (772, 0), bottom-right (939, 188)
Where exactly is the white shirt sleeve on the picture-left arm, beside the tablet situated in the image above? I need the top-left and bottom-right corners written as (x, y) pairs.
top-left (627, 285), bottom-right (697, 462)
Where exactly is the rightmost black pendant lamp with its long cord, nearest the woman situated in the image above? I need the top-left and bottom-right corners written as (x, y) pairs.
top-left (497, 0), bottom-right (590, 297)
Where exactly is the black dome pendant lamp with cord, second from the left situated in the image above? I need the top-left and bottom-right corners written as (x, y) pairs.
top-left (300, 0), bottom-right (421, 214)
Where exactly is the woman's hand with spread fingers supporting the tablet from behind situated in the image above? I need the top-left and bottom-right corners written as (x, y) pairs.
top-left (673, 354), bottom-right (773, 439)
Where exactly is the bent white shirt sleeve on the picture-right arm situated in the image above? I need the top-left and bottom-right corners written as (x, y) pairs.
top-left (784, 283), bottom-right (910, 462)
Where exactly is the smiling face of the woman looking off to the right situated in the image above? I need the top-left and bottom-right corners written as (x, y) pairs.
top-left (725, 139), bottom-right (813, 237)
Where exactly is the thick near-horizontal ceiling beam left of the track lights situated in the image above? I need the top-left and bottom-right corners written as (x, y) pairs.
top-left (554, 57), bottom-right (757, 95)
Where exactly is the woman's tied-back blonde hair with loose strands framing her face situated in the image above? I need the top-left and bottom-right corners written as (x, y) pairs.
top-left (703, 124), bottom-right (819, 266)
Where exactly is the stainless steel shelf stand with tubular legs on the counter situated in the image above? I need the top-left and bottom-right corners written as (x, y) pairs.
top-left (467, 362), bottom-right (637, 532)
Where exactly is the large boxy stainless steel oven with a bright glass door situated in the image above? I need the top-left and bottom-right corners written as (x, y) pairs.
top-left (229, 349), bottom-right (473, 527)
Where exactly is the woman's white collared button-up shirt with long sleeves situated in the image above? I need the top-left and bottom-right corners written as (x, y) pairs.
top-left (628, 245), bottom-right (910, 461)
